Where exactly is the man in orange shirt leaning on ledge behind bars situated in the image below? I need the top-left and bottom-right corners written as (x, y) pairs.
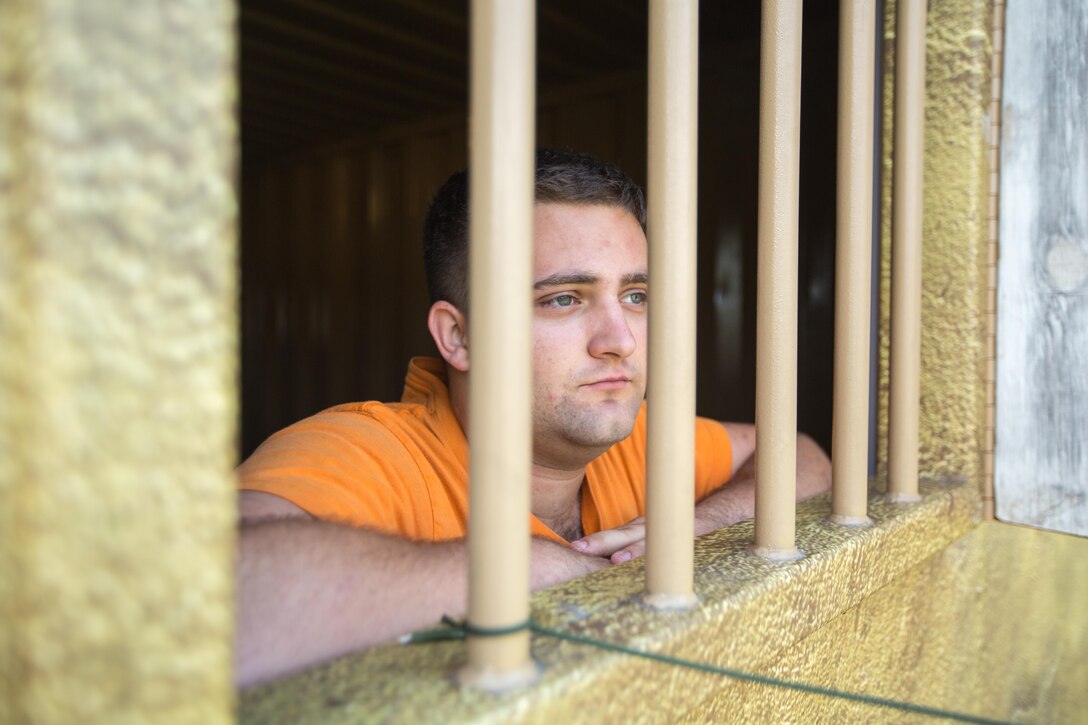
top-left (237, 151), bottom-right (830, 685)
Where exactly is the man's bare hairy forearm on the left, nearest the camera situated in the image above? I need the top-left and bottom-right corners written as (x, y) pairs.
top-left (235, 491), bottom-right (608, 687)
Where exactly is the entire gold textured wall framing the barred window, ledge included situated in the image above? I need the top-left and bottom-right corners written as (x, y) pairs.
top-left (0, 0), bottom-right (1061, 723)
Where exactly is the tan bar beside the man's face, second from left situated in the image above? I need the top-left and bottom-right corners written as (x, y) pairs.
top-left (646, 0), bottom-right (698, 609)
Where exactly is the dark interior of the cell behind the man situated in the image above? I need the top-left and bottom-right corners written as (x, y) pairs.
top-left (239, 0), bottom-right (838, 456)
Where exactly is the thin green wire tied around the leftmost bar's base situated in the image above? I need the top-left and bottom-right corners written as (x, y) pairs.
top-left (400, 617), bottom-right (1012, 725)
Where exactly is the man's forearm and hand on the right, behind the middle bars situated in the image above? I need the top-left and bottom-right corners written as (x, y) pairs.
top-left (571, 422), bottom-right (831, 564)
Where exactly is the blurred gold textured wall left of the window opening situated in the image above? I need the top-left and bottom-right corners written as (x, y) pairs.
top-left (0, 0), bottom-right (237, 723)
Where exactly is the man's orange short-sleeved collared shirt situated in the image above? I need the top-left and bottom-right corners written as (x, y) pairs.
top-left (238, 358), bottom-right (732, 541)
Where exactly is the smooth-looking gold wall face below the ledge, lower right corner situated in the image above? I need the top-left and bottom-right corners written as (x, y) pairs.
top-left (684, 523), bottom-right (1088, 724)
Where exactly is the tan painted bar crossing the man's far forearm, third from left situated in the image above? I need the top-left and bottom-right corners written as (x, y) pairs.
top-left (754, 0), bottom-right (803, 561)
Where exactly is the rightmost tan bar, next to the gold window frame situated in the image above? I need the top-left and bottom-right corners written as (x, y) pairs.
top-left (888, 0), bottom-right (926, 503)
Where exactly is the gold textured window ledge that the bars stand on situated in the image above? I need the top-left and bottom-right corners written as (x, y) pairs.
top-left (240, 484), bottom-right (979, 723)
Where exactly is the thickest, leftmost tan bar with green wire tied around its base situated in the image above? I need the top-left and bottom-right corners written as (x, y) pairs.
top-left (459, 0), bottom-right (536, 691)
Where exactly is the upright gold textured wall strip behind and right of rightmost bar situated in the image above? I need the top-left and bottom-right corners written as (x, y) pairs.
top-left (878, 0), bottom-right (993, 480)
